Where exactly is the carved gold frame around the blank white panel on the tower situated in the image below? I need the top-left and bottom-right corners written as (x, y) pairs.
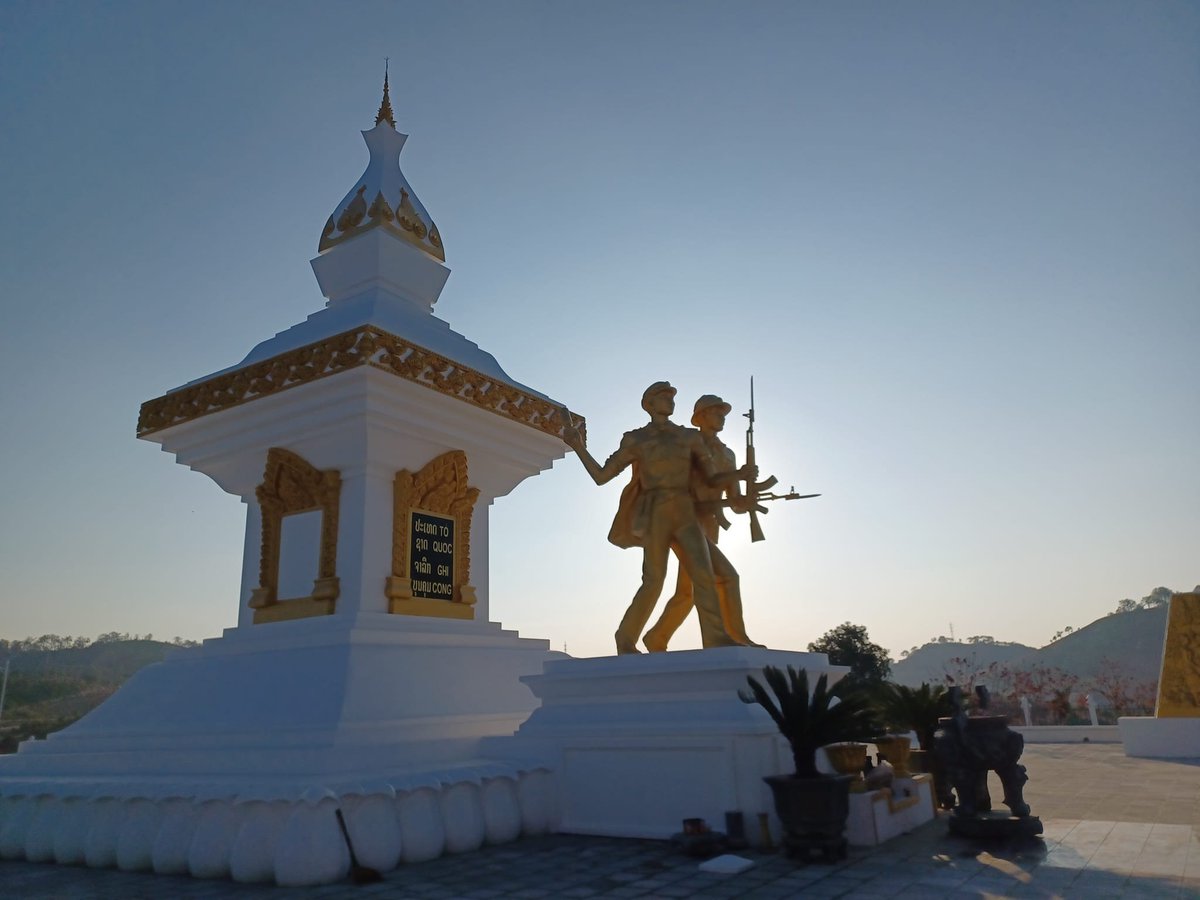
top-left (250, 446), bottom-right (342, 624)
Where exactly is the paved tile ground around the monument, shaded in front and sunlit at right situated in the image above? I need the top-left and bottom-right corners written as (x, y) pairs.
top-left (0, 744), bottom-right (1200, 900)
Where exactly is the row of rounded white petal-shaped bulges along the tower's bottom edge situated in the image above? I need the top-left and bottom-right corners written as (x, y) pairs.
top-left (0, 762), bottom-right (556, 886)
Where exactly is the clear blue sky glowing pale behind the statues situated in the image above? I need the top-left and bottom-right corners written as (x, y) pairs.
top-left (0, 0), bottom-right (1200, 655)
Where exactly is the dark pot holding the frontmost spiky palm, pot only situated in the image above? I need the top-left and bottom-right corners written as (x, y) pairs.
top-left (763, 775), bottom-right (854, 860)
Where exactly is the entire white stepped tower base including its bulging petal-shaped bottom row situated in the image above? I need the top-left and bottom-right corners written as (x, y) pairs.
top-left (0, 614), bottom-right (562, 884)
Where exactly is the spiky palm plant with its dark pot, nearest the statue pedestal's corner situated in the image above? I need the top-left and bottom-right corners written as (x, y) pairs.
top-left (738, 666), bottom-right (874, 859)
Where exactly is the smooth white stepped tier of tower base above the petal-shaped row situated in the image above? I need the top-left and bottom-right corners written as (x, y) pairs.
top-left (0, 613), bottom-right (563, 794)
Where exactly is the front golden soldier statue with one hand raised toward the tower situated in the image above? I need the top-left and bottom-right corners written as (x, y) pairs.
top-left (563, 382), bottom-right (757, 653)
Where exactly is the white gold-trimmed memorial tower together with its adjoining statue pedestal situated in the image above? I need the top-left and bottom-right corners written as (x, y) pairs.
top-left (0, 79), bottom-right (841, 884)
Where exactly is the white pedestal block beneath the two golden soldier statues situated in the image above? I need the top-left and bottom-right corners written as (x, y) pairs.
top-left (484, 647), bottom-right (848, 840)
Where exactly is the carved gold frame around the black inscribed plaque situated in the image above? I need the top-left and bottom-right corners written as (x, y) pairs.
top-left (385, 450), bottom-right (479, 619)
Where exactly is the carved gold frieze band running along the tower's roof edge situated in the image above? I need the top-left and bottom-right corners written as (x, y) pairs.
top-left (138, 325), bottom-right (586, 446)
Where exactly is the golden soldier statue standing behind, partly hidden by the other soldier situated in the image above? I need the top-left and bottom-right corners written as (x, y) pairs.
top-left (642, 394), bottom-right (760, 652)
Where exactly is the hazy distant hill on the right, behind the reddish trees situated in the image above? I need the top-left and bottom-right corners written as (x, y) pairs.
top-left (892, 606), bottom-right (1166, 686)
